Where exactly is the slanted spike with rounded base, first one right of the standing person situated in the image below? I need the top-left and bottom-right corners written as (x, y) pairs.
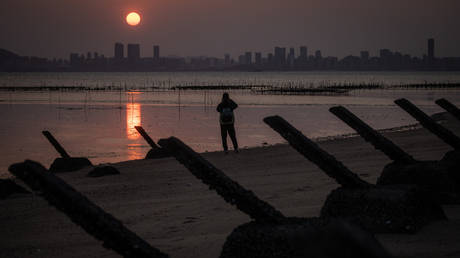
top-left (264, 116), bottom-right (446, 233)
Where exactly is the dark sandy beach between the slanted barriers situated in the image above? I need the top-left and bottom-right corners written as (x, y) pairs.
top-left (0, 114), bottom-right (460, 258)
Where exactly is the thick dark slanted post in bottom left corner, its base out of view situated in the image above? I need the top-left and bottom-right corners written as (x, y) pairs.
top-left (9, 160), bottom-right (168, 258)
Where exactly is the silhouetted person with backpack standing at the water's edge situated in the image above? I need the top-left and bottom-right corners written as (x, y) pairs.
top-left (216, 92), bottom-right (238, 154)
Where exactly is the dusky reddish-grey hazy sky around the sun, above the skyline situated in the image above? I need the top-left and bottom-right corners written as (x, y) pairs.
top-left (0, 0), bottom-right (460, 58)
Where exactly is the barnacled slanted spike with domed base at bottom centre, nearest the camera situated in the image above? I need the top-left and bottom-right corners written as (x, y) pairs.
top-left (159, 137), bottom-right (389, 258)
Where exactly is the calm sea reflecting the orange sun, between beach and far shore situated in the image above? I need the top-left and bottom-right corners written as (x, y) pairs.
top-left (0, 72), bottom-right (460, 177)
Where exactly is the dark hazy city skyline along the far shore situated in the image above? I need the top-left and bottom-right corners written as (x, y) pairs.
top-left (0, 38), bottom-right (460, 72)
